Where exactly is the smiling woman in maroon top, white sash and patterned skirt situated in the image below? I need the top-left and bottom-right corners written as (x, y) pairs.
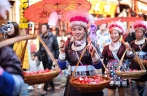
top-left (102, 21), bottom-right (133, 96)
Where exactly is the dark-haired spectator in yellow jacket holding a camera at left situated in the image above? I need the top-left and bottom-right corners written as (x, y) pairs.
top-left (8, 22), bottom-right (29, 71)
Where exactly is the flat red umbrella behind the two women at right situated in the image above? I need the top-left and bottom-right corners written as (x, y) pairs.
top-left (95, 17), bottom-right (143, 25)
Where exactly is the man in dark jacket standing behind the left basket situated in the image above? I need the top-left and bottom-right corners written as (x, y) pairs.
top-left (38, 24), bottom-right (59, 95)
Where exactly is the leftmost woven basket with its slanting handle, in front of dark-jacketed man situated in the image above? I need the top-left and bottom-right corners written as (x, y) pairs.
top-left (24, 34), bottom-right (60, 85)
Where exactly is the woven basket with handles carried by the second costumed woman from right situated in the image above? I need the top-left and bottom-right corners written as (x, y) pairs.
top-left (116, 49), bottom-right (146, 79)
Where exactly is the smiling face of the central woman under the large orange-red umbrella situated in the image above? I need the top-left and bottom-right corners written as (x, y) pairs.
top-left (72, 25), bottom-right (86, 41)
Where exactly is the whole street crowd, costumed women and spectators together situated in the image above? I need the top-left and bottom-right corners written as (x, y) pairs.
top-left (0, 0), bottom-right (147, 96)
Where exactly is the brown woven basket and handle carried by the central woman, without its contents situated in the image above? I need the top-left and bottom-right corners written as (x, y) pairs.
top-left (70, 48), bottom-right (111, 92)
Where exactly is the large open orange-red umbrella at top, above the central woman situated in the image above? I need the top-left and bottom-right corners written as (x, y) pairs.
top-left (24, 0), bottom-right (91, 23)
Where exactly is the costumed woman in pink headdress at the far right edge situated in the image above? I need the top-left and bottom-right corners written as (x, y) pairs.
top-left (130, 21), bottom-right (147, 96)
